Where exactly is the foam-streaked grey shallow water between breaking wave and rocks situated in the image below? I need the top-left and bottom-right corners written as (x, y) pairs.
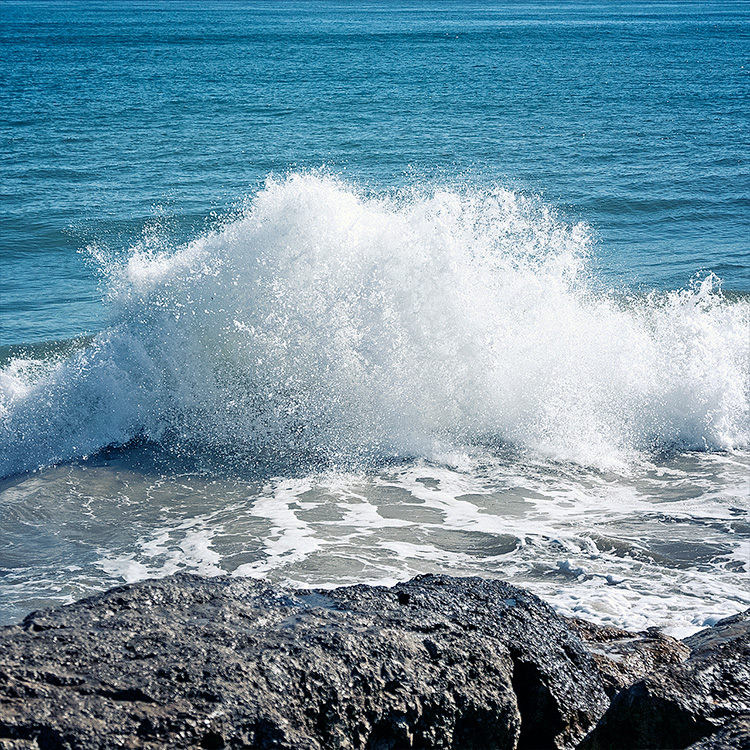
top-left (0, 451), bottom-right (750, 636)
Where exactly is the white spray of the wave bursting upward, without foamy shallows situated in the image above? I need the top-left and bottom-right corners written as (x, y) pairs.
top-left (0, 174), bottom-right (750, 475)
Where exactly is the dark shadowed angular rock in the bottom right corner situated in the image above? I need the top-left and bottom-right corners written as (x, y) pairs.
top-left (581, 610), bottom-right (750, 750)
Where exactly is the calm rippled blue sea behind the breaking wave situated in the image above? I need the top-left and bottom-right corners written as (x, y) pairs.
top-left (0, 0), bottom-right (750, 344)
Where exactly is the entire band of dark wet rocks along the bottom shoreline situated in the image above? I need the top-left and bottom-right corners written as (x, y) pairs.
top-left (0, 574), bottom-right (750, 750)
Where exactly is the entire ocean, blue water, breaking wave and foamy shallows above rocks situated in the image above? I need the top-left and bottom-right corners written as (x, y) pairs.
top-left (0, 0), bottom-right (750, 636)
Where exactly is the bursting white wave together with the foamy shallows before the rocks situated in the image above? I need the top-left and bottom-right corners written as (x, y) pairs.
top-left (0, 172), bottom-right (750, 634)
